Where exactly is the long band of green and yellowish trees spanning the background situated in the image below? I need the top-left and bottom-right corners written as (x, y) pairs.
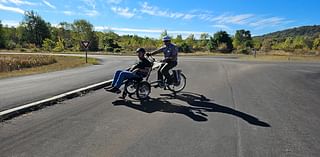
top-left (0, 11), bottom-right (320, 54)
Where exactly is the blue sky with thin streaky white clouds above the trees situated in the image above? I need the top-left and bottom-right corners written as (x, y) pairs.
top-left (0, 0), bottom-right (320, 38)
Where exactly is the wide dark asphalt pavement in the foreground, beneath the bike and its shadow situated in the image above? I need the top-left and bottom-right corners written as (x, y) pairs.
top-left (0, 58), bottom-right (320, 157)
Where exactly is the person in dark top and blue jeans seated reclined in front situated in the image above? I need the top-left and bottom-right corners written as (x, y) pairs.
top-left (106, 48), bottom-right (152, 94)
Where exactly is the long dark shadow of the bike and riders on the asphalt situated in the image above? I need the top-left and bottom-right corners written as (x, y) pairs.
top-left (112, 92), bottom-right (271, 127)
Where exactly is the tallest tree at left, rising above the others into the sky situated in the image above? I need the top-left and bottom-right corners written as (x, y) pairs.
top-left (22, 11), bottom-right (50, 47)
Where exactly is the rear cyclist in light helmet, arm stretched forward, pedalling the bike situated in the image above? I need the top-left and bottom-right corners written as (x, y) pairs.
top-left (146, 36), bottom-right (178, 86)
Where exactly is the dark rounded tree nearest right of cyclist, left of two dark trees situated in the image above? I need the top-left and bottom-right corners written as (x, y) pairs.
top-left (213, 31), bottom-right (233, 53)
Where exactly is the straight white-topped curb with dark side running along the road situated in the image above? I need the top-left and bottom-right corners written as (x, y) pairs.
top-left (0, 79), bottom-right (112, 122)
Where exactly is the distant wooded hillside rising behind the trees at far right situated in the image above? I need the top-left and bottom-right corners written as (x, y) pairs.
top-left (255, 25), bottom-right (320, 39)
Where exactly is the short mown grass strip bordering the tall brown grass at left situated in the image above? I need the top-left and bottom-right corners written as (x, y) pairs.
top-left (0, 55), bottom-right (98, 78)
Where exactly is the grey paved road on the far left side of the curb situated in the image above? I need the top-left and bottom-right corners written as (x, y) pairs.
top-left (0, 56), bottom-right (136, 111)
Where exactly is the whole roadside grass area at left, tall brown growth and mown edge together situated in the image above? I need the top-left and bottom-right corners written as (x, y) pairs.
top-left (0, 54), bottom-right (98, 78)
